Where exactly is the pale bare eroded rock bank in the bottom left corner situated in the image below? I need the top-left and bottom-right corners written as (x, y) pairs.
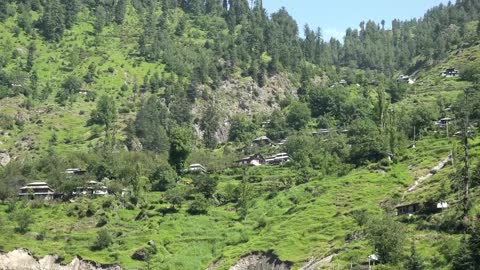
top-left (0, 249), bottom-right (122, 270)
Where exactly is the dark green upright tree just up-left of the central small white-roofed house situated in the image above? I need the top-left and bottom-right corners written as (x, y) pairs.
top-left (169, 127), bottom-right (193, 172)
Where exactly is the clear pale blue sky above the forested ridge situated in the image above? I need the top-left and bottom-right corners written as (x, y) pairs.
top-left (263, 0), bottom-right (455, 40)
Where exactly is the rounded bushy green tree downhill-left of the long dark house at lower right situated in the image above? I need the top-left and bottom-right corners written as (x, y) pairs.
top-left (366, 214), bottom-right (405, 264)
